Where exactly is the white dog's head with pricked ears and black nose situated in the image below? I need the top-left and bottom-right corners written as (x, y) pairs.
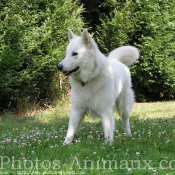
top-left (57, 30), bottom-right (95, 76)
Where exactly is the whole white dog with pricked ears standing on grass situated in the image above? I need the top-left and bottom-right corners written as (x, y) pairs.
top-left (58, 30), bottom-right (139, 145)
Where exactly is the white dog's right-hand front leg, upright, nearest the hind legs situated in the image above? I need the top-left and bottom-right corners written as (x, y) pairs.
top-left (100, 109), bottom-right (115, 144)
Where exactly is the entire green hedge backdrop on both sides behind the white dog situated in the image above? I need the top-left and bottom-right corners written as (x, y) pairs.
top-left (0, 0), bottom-right (175, 110)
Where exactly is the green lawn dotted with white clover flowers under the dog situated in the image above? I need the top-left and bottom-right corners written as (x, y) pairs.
top-left (0, 102), bottom-right (175, 175)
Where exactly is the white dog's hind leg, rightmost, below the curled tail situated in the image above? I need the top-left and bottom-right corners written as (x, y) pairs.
top-left (116, 87), bottom-right (134, 136)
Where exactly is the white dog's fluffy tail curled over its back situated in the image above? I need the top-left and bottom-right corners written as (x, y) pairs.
top-left (109, 46), bottom-right (139, 66)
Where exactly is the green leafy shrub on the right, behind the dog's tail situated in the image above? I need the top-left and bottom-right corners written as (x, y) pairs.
top-left (95, 0), bottom-right (175, 101)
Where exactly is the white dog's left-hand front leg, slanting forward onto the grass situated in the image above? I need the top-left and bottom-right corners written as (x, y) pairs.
top-left (63, 108), bottom-right (85, 145)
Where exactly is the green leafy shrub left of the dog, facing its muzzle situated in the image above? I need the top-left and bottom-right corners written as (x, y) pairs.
top-left (0, 0), bottom-right (83, 110)
